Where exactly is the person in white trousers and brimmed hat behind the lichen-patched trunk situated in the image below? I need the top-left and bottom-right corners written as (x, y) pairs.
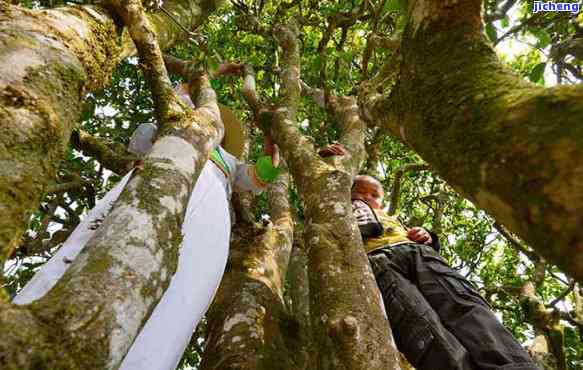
top-left (13, 84), bottom-right (279, 370)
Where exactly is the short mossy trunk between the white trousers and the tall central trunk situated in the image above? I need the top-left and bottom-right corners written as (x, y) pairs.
top-left (201, 174), bottom-right (299, 370)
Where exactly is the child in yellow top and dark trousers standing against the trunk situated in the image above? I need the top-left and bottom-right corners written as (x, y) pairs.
top-left (320, 145), bottom-right (539, 370)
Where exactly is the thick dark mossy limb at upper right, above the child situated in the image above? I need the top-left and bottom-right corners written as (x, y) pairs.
top-left (361, 0), bottom-right (583, 281)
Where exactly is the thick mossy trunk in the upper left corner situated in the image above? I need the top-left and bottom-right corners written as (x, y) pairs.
top-left (0, 0), bottom-right (225, 272)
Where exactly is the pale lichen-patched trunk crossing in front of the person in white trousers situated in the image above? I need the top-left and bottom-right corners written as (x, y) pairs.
top-left (0, 1), bottom-right (222, 364)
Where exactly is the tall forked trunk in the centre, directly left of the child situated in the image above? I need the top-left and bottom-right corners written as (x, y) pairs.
top-left (264, 24), bottom-right (399, 370)
